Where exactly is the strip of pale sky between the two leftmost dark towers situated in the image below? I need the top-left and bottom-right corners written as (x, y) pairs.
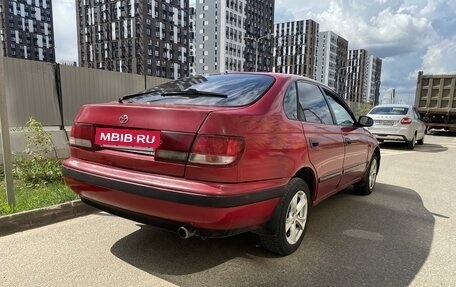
top-left (52, 0), bottom-right (78, 62)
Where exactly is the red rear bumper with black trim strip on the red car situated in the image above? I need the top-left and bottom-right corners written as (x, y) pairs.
top-left (62, 158), bottom-right (286, 236)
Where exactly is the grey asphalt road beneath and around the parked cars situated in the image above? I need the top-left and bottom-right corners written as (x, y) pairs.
top-left (0, 136), bottom-right (456, 286)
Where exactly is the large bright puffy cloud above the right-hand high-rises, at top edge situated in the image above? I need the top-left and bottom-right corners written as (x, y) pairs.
top-left (300, 1), bottom-right (438, 57)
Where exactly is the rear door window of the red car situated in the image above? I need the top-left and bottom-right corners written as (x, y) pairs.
top-left (298, 82), bottom-right (333, 125)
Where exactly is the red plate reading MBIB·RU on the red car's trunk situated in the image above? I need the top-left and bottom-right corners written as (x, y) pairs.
top-left (95, 128), bottom-right (160, 149)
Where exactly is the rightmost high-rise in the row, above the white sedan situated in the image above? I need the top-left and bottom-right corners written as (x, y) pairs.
top-left (344, 49), bottom-right (382, 104)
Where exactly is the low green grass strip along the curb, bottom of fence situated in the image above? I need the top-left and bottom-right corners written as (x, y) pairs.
top-left (0, 179), bottom-right (78, 216)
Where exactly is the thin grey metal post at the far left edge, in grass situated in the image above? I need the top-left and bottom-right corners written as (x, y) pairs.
top-left (0, 55), bottom-right (16, 206)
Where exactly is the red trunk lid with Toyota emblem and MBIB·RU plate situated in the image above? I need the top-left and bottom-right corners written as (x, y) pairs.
top-left (70, 103), bottom-right (223, 177)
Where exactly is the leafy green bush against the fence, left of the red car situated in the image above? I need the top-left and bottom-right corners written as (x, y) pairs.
top-left (14, 118), bottom-right (62, 186)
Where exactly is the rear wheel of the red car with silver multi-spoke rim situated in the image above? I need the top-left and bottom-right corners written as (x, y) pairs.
top-left (260, 178), bottom-right (311, 255)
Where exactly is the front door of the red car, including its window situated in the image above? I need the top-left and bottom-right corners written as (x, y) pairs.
top-left (324, 89), bottom-right (369, 189)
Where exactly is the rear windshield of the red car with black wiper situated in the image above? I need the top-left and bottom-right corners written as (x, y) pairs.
top-left (127, 74), bottom-right (274, 106)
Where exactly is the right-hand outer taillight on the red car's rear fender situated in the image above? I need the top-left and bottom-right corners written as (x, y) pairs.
top-left (188, 135), bottom-right (244, 165)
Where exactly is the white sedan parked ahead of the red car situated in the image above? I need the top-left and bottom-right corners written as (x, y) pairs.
top-left (367, 104), bottom-right (426, 150)
